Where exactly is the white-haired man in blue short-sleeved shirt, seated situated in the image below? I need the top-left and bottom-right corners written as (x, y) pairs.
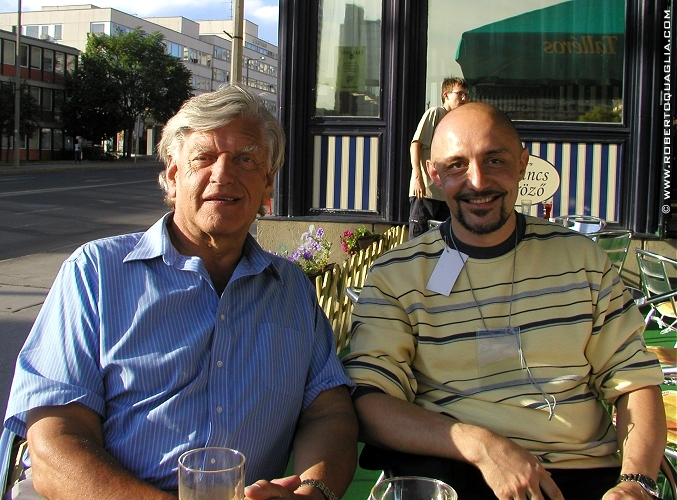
top-left (5, 85), bottom-right (357, 500)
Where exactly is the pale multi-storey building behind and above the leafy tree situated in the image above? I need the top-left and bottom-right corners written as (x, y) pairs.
top-left (0, 4), bottom-right (278, 155)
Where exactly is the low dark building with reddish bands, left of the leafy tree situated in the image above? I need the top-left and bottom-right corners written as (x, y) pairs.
top-left (0, 30), bottom-right (79, 161)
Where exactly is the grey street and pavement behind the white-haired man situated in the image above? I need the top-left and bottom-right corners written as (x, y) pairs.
top-left (0, 166), bottom-right (169, 416)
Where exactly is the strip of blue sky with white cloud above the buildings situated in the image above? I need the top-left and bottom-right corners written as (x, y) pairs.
top-left (0, 0), bottom-right (279, 45)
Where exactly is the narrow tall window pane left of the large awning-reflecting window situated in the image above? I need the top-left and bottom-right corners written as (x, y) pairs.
top-left (315, 0), bottom-right (382, 116)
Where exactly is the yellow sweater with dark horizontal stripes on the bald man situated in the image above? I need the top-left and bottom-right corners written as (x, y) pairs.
top-left (344, 217), bottom-right (663, 468)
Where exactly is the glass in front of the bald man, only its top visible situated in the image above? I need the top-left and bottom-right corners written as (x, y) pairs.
top-left (369, 476), bottom-right (458, 500)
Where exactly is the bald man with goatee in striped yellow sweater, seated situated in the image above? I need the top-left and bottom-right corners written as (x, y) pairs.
top-left (344, 103), bottom-right (666, 500)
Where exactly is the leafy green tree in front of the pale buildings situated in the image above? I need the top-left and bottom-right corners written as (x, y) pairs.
top-left (64, 28), bottom-right (191, 155)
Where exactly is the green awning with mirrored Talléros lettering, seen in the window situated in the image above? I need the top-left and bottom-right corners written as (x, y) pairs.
top-left (456, 0), bottom-right (625, 85)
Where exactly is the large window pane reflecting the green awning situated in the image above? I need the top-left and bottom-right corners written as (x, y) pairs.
top-left (426, 0), bottom-right (626, 122)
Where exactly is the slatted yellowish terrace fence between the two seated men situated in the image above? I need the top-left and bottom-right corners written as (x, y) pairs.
top-left (315, 226), bottom-right (407, 353)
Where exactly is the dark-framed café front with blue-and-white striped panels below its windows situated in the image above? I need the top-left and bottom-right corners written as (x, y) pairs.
top-left (275, 0), bottom-right (677, 236)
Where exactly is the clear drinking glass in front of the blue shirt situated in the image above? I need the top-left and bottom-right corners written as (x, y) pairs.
top-left (179, 448), bottom-right (245, 500)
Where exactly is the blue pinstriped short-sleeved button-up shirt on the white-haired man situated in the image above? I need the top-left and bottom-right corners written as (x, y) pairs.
top-left (5, 214), bottom-right (352, 489)
